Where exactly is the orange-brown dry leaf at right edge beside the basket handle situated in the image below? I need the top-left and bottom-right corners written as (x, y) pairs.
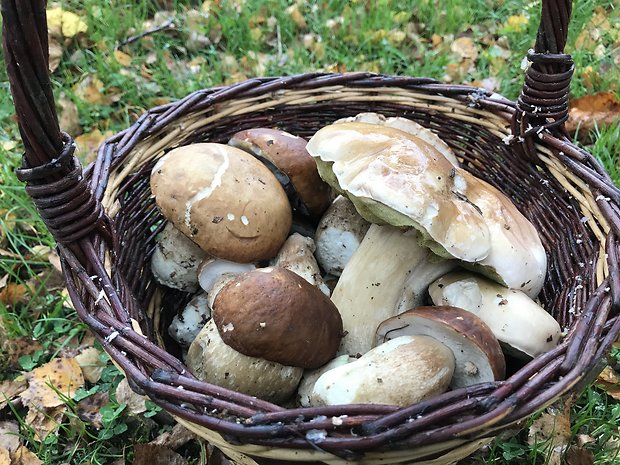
top-left (566, 92), bottom-right (620, 134)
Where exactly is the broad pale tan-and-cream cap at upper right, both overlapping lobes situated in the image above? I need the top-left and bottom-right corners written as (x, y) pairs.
top-left (307, 118), bottom-right (546, 296)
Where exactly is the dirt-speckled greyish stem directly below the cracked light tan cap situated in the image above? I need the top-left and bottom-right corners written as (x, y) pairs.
top-left (151, 223), bottom-right (208, 292)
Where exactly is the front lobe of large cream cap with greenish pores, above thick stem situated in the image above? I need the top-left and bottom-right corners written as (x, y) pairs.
top-left (307, 123), bottom-right (491, 262)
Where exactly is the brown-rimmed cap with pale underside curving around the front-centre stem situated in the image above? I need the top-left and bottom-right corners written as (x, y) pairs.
top-left (376, 307), bottom-right (506, 389)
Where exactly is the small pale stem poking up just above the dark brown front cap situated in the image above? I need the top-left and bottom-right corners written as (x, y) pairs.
top-left (272, 233), bottom-right (330, 297)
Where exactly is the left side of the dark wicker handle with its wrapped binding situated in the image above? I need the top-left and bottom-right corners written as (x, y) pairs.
top-left (2, 0), bottom-right (107, 244)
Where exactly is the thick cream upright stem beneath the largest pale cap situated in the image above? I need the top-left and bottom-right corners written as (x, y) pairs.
top-left (332, 224), bottom-right (447, 355)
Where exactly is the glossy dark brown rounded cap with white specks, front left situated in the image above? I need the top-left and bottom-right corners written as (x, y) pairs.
top-left (213, 268), bottom-right (342, 368)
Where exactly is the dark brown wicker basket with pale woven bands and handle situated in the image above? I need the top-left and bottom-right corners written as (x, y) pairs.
top-left (2, 0), bottom-right (620, 464)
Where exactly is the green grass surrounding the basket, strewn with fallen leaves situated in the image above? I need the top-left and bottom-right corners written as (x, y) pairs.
top-left (0, 0), bottom-right (620, 465)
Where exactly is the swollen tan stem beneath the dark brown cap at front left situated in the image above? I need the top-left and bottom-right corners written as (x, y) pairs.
top-left (185, 319), bottom-right (304, 403)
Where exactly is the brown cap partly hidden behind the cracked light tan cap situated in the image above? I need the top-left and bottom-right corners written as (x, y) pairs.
top-left (228, 128), bottom-right (332, 218)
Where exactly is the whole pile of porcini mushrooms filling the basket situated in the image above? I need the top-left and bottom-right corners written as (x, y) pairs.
top-left (151, 113), bottom-right (561, 407)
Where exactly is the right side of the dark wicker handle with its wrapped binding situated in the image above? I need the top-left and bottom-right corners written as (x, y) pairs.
top-left (512, 0), bottom-right (575, 158)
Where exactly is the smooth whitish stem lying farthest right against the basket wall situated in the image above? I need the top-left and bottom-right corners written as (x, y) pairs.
top-left (429, 272), bottom-right (562, 360)
